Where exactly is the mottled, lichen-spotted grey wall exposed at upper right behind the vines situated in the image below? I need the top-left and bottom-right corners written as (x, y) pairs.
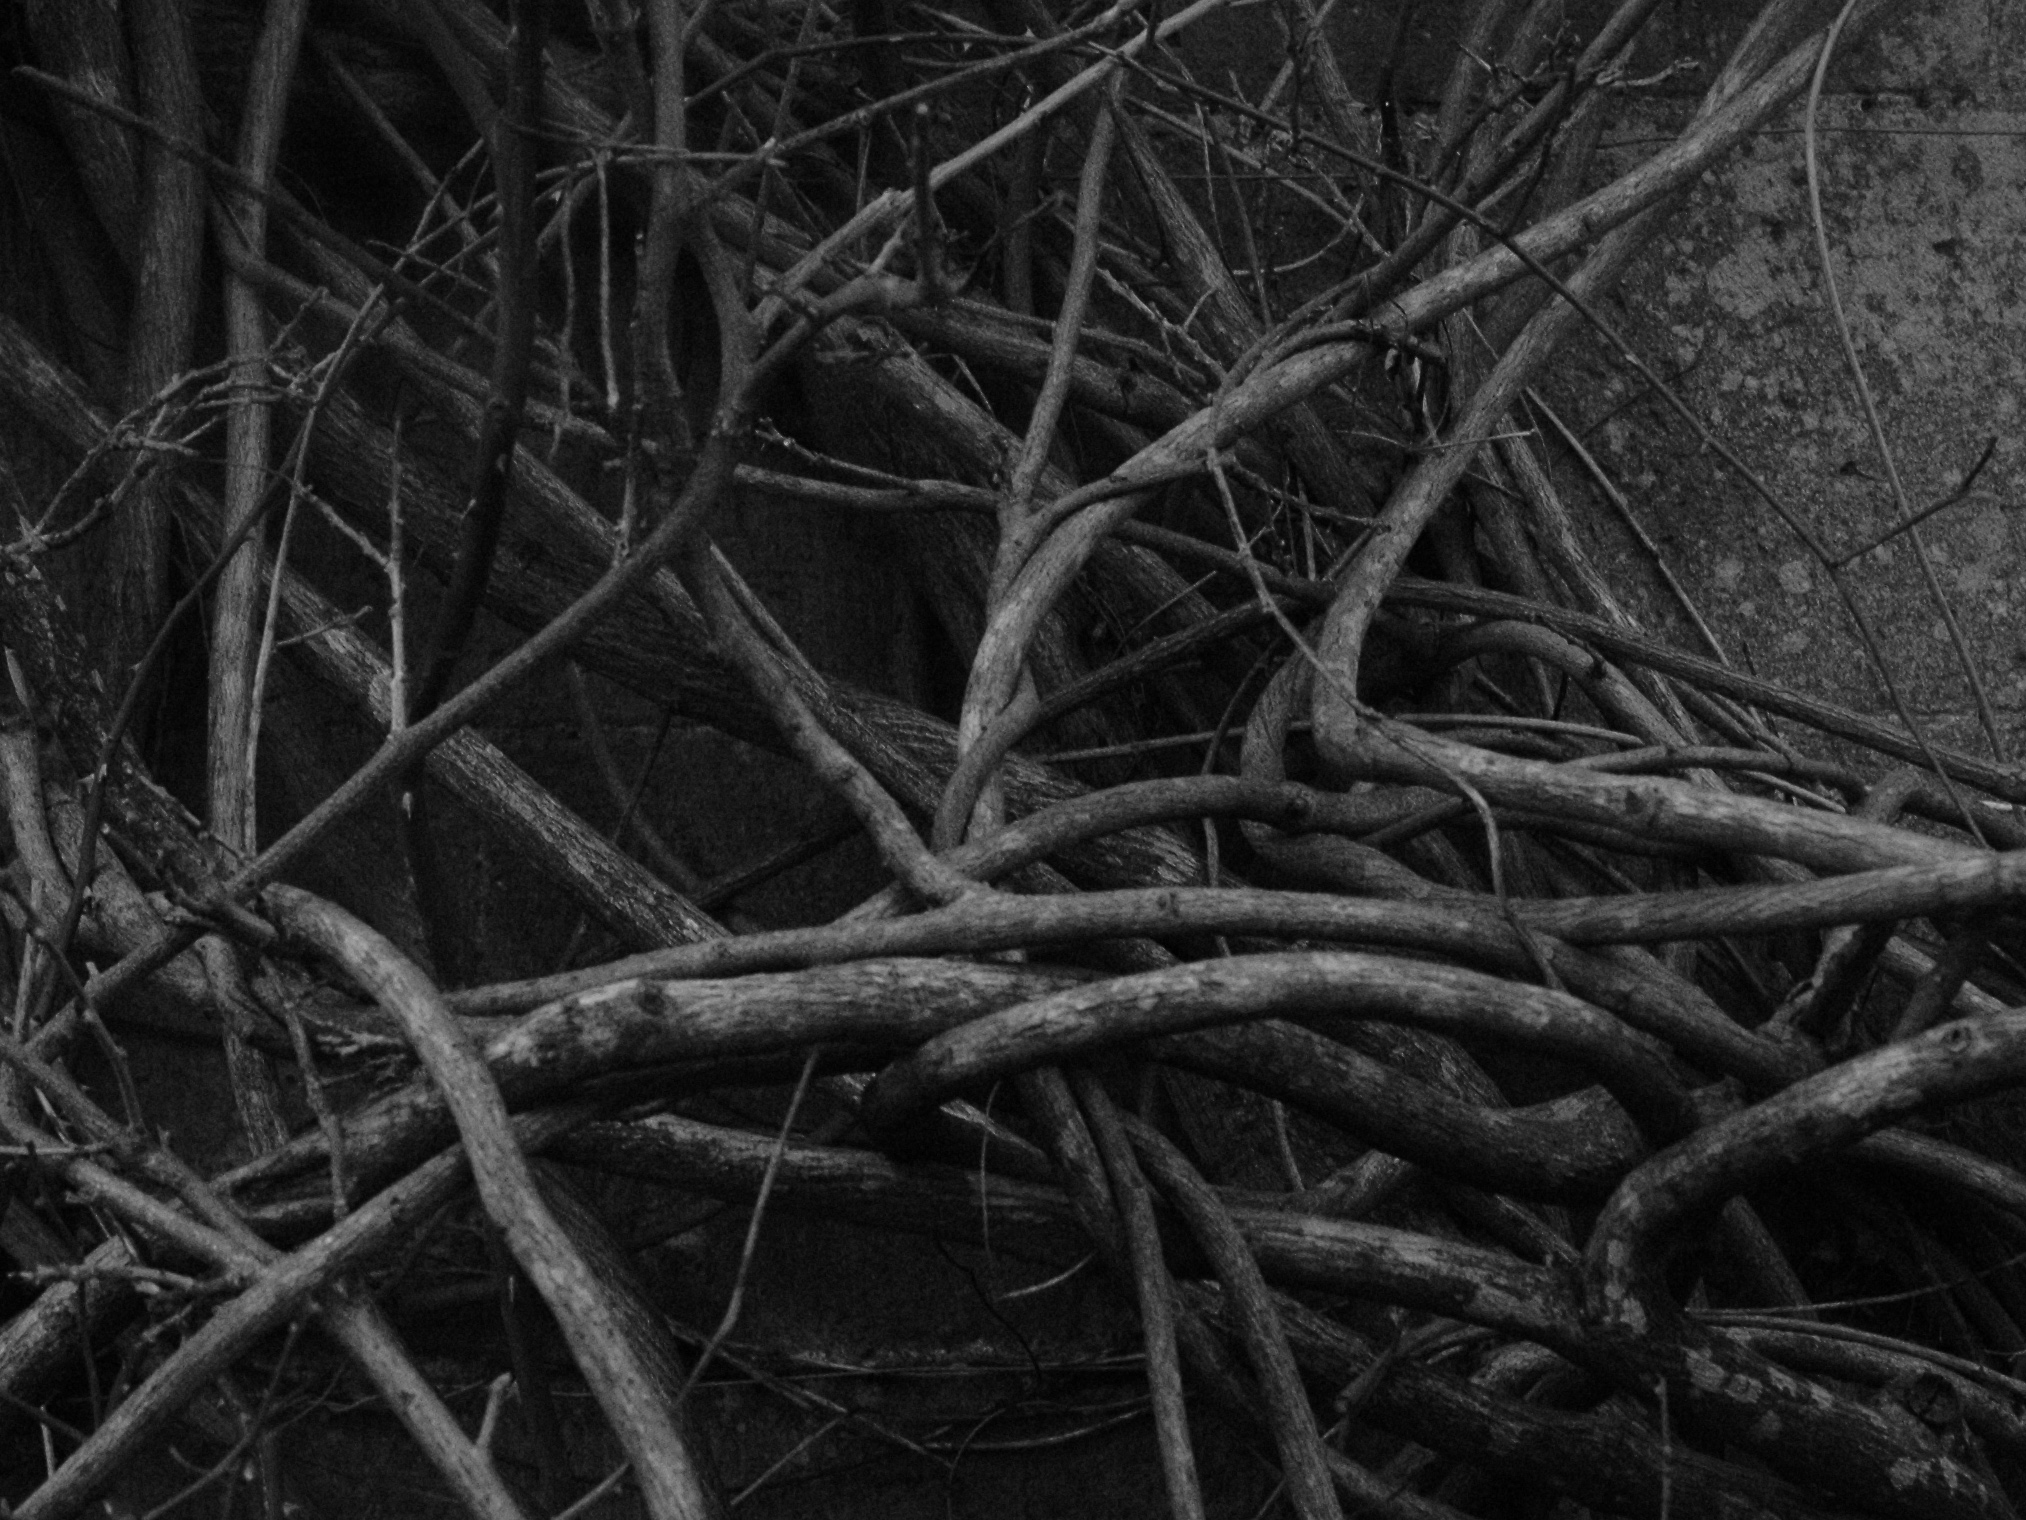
top-left (1552, 0), bottom-right (2026, 754)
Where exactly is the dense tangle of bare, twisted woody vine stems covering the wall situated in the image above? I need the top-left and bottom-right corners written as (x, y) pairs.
top-left (0, 0), bottom-right (2026, 1520)
